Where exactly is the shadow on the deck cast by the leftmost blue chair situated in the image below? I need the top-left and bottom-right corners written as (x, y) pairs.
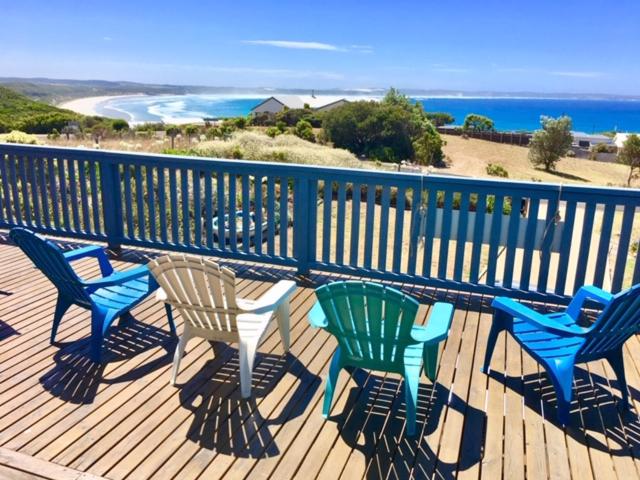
top-left (39, 318), bottom-right (176, 404)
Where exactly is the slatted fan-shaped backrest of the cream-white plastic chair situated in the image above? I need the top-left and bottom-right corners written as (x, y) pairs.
top-left (149, 253), bottom-right (240, 333)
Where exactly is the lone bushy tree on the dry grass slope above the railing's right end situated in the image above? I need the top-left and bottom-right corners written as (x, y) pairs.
top-left (529, 116), bottom-right (573, 172)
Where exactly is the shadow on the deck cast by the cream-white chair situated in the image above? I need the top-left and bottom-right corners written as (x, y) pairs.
top-left (178, 342), bottom-right (321, 458)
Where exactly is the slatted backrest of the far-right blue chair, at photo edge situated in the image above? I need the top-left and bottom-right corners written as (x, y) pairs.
top-left (580, 285), bottom-right (640, 356)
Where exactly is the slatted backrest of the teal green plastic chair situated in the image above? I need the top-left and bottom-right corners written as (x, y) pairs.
top-left (316, 281), bottom-right (418, 371)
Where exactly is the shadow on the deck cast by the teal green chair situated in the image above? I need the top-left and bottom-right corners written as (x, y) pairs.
top-left (330, 369), bottom-right (486, 479)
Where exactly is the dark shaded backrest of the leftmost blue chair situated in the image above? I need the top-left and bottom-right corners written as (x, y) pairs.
top-left (9, 227), bottom-right (91, 305)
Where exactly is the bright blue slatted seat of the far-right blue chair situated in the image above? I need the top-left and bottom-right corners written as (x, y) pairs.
top-left (513, 313), bottom-right (585, 359)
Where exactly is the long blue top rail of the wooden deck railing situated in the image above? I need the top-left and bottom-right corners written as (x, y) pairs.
top-left (0, 143), bottom-right (640, 201)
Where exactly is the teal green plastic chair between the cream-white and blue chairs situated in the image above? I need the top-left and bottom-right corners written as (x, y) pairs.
top-left (309, 281), bottom-right (453, 435)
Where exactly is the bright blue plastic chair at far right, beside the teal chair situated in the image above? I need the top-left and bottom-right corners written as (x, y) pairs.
top-left (483, 285), bottom-right (640, 425)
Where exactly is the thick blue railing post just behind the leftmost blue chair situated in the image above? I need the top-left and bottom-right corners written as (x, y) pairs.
top-left (100, 160), bottom-right (123, 254)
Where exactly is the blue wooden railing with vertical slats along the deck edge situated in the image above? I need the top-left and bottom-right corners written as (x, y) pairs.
top-left (0, 144), bottom-right (640, 301)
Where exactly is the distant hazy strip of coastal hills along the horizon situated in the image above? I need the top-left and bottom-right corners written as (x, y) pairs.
top-left (0, 77), bottom-right (640, 104)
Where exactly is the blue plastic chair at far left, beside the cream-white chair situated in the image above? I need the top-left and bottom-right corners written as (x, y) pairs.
top-left (9, 227), bottom-right (176, 362)
